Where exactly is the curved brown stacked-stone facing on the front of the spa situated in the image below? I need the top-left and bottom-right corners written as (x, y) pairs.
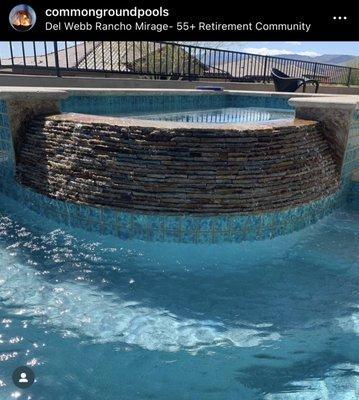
top-left (16, 114), bottom-right (339, 215)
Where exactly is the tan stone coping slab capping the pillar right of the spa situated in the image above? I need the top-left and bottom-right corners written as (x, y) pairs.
top-left (288, 95), bottom-right (359, 110)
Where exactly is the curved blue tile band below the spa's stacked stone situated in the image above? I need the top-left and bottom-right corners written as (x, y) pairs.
top-left (2, 181), bottom-right (342, 243)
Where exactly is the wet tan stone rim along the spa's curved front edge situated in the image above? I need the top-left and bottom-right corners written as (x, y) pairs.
top-left (46, 113), bottom-right (317, 132)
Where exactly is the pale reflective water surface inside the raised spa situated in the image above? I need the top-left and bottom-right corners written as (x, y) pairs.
top-left (128, 107), bottom-right (294, 123)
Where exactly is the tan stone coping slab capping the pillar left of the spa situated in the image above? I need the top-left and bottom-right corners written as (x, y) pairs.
top-left (0, 86), bottom-right (69, 101)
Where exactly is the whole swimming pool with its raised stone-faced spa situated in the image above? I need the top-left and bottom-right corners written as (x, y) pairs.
top-left (0, 90), bottom-right (359, 400)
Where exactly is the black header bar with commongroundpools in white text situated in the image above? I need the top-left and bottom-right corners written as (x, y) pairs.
top-left (0, 0), bottom-right (359, 41)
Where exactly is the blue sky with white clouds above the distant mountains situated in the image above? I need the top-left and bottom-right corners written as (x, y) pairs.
top-left (217, 42), bottom-right (359, 57)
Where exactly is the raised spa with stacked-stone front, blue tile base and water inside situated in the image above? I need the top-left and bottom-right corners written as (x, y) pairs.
top-left (1, 91), bottom-right (356, 242)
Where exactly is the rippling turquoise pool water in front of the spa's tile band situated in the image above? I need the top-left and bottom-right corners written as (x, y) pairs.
top-left (0, 192), bottom-right (359, 400)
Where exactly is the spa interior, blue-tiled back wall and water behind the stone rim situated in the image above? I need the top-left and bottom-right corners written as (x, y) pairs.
top-left (61, 93), bottom-right (294, 123)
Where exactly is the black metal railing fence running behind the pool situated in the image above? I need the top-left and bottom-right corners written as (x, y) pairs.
top-left (0, 41), bottom-right (359, 86)
